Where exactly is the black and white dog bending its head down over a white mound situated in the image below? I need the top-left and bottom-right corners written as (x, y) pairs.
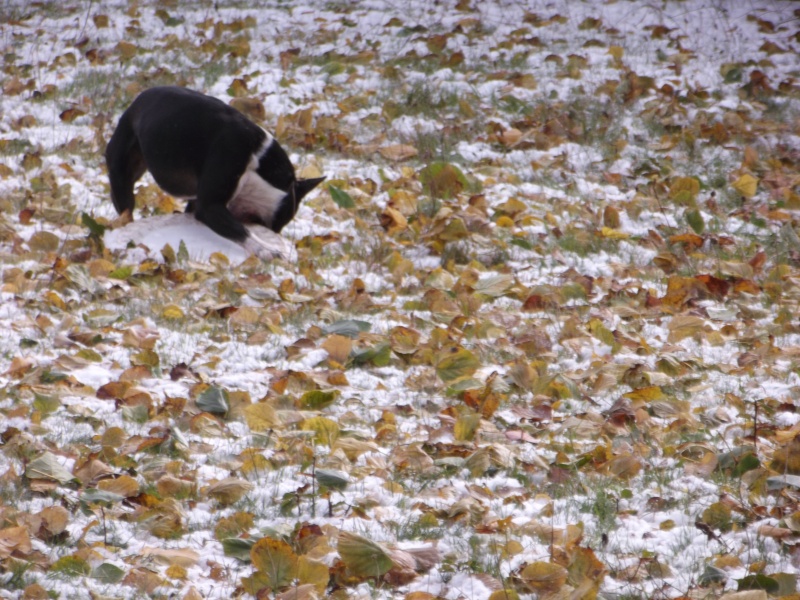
top-left (106, 87), bottom-right (325, 258)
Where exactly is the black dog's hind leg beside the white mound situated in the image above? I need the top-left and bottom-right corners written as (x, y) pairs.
top-left (106, 114), bottom-right (147, 214)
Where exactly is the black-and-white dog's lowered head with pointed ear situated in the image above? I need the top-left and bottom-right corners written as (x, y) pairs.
top-left (239, 136), bottom-right (325, 233)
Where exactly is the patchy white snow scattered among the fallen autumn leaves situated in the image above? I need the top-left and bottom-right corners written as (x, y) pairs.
top-left (0, 0), bottom-right (800, 600)
